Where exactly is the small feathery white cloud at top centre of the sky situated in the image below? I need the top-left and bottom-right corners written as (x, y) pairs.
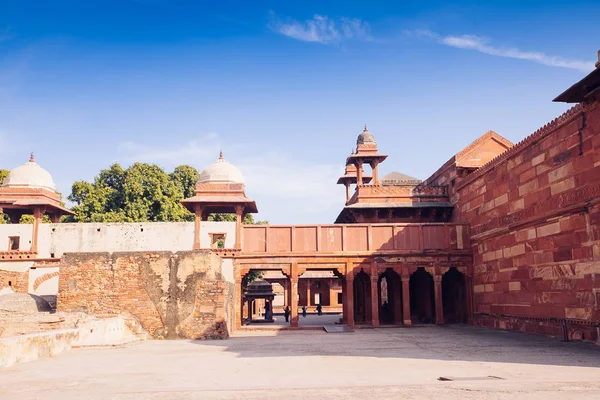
top-left (268, 13), bottom-right (371, 44)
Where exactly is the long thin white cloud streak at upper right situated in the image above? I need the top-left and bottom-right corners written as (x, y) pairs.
top-left (405, 30), bottom-right (594, 72)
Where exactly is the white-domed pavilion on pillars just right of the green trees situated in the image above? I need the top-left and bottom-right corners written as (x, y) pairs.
top-left (181, 152), bottom-right (258, 250)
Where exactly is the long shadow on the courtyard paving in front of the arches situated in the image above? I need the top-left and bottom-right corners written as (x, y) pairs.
top-left (193, 325), bottom-right (600, 368)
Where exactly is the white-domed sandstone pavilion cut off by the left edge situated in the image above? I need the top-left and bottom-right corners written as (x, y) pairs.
top-left (0, 153), bottom-right (74, 254)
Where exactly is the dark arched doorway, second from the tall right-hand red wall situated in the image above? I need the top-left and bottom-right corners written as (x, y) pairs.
top-left (409, 267), bottom-right (435, 324)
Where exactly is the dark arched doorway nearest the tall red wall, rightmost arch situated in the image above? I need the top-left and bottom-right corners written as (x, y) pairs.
top-left (442, 267), bottom-right (467, 324)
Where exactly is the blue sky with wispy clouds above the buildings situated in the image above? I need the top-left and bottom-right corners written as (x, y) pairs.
top-left (0, 0), bottom-right (600, 223)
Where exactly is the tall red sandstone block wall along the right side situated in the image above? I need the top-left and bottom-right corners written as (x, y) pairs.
top-left (453, 103), bottom-right (600, 341)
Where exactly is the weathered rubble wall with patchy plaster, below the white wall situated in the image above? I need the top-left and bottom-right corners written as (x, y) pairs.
top-left (57, 251), bottom-right (233, 339)
